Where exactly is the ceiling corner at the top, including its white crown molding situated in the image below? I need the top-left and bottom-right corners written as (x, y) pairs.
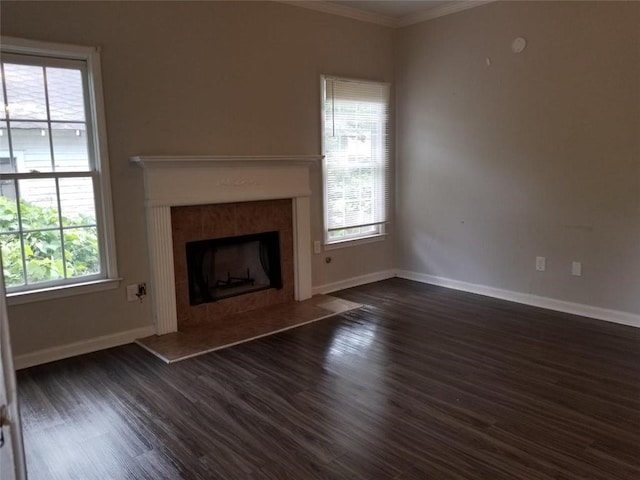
top-left (279, 0), bottom-right (495, 27)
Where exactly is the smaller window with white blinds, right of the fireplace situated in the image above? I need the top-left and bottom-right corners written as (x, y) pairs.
top-left (322, 76), bottom-right (389, 248)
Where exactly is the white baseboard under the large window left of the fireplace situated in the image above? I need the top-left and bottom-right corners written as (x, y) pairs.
top-left (13, 325), bottom-right (156, 370)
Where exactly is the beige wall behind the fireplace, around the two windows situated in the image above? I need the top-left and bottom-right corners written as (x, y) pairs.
top-left (1, 1), bottom-right (393, 354)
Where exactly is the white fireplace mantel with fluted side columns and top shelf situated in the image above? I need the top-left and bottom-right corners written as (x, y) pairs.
top-left (131, 155), bottom-right (322, 335)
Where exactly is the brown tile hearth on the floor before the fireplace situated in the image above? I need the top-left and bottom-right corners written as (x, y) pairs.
top-left (136, 295), bottom-right (363, 363)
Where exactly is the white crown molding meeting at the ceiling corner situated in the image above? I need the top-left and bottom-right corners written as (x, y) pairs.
top-left (276, 0), bottom-right (498, 28)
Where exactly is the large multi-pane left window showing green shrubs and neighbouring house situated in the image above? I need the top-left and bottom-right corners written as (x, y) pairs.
top-left (0, 38), bottom-right (117, 300)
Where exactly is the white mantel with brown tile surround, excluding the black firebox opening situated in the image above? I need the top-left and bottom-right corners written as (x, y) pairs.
top-left (131, 155), bottom-right (322, 335)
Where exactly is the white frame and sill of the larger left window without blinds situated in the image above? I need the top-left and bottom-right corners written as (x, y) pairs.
top-left (0, 36), bottom-right (122, 305)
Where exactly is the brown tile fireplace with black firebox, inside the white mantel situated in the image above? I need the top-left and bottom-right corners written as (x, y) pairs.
top-left (171, 199), bottom-right (296, 329)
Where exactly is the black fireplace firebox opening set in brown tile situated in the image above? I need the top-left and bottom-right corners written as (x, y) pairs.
top-left (186, 231), bottom-right (282, 305)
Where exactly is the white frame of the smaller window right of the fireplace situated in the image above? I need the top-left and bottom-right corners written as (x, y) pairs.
top-left (320, 75), bottom-right (391, 250)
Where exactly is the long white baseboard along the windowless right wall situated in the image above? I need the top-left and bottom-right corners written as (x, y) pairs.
top-left (396, 270), bottom-right (640, 328)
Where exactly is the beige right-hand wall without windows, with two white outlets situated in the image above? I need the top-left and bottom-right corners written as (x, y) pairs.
top-left (395, 2), bottom-right (640, 314)
